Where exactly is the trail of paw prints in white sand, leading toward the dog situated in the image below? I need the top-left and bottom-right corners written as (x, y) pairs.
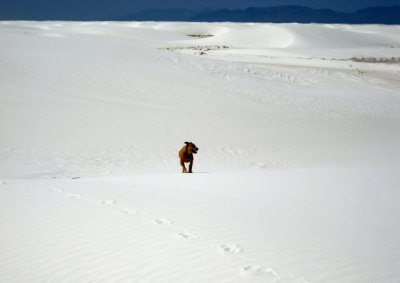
top-left (50, 188), bottom-right (309, 283)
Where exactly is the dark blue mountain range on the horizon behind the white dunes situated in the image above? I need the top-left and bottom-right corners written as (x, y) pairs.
top-left (111, 6), bottom-right (400, 25)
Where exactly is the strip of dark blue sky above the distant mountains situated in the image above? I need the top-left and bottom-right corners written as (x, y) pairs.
top-left (0, 0), bottom-right (400, 18)
